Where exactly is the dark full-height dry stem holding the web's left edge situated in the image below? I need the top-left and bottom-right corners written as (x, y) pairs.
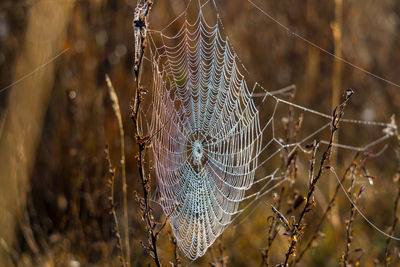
top-left (131, 0), bottom-right (161, 266)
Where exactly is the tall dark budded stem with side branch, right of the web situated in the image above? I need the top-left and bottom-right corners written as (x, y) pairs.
top-left (283, 90), bottom-right (353, 267)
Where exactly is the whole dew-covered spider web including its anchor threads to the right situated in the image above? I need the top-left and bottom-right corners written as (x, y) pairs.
top-left (136, 1), bottom-right (395, 260)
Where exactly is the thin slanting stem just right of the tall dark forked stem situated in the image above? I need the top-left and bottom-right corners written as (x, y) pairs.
top-left (295, 153), bottom-right (360, 264)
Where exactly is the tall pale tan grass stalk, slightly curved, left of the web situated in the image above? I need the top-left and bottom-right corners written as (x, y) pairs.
top-left (106, 75), bottom-right (131, 267)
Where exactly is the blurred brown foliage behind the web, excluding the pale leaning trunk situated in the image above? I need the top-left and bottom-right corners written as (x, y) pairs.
top-left (0, 0), bottom-right (400, 266)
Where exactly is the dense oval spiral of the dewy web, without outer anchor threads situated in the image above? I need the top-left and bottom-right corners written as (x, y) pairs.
top-left (152, 12), bottom-right (262, 259)
